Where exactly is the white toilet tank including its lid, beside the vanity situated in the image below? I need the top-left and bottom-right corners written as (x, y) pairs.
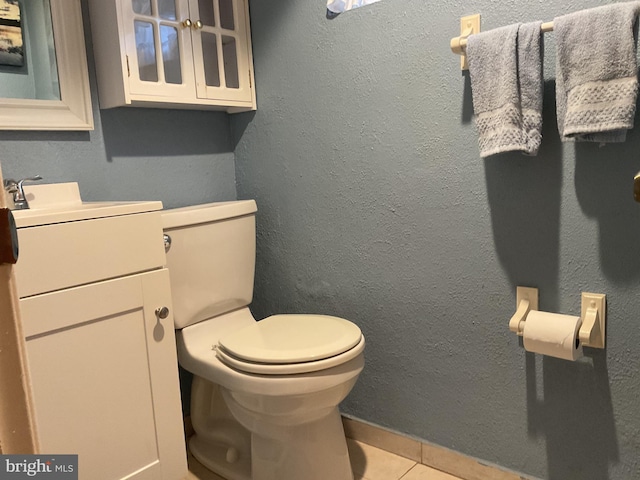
top-left (162, 200), bottom-right (257, 329)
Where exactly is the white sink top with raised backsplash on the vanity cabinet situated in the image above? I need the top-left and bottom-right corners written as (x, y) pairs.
top-left (12, 182), bottom-right (162, 228)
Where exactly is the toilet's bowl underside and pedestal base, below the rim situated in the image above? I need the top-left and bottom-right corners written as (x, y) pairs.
top-left (190, 355), bottom-right (364, 480)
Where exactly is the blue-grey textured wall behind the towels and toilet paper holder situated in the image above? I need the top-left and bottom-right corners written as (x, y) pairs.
top-left (232, 0), bottom-right (640, 480)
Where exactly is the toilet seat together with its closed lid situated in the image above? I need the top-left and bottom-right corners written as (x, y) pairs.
top-left (216, 315), bottom-right (364, 375)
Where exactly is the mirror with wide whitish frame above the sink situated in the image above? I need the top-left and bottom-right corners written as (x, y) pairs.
top-left (0, 0), bottom-right (93, 130)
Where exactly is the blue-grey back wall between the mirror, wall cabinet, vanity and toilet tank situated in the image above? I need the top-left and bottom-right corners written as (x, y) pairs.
top-left (0, 0), bottom-right (236, 208)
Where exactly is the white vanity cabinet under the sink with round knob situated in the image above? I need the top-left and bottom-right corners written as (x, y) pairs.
top-left (14, 202), bottom-right (187, 480)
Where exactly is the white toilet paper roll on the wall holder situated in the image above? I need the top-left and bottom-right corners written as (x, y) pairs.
top-left (522, 310), bottom-right (582, 360)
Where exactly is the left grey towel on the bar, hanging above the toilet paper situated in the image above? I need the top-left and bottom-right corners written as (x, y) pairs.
top-left (467, 22), bottom-right (543, 157)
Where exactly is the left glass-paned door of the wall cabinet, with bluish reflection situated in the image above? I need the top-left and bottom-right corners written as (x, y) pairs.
top-left (123, 0), bottom-right (194, 96)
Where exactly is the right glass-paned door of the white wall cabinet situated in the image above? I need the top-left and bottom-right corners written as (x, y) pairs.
top-left (189, 0), bottom-right (252, 101)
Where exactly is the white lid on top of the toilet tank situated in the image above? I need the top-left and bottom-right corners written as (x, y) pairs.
top-left (162, 200), bottom-right (258, 229)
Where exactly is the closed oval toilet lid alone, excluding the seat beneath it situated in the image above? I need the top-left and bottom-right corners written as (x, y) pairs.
top-left (218, 315), bottom-right (362, 364)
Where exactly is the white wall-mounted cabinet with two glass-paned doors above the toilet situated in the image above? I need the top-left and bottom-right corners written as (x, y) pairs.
top-left (89, 0), bottom-right (256, 113)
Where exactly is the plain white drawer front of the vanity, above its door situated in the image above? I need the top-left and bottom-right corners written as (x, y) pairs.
top-left (14, 212), bottom-right (165, 298)
